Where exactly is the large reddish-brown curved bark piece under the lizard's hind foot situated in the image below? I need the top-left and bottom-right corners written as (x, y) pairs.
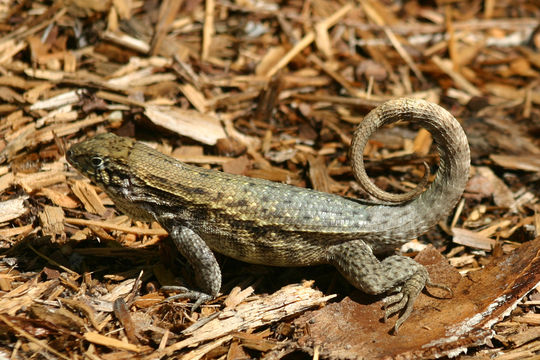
top-left (294, 239), bottom-right (540, 359)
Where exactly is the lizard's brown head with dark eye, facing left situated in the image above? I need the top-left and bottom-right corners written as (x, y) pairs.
top-left (66, 133), bottom-right (135, 187)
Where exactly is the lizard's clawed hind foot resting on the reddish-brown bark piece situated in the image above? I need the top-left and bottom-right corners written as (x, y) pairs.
top-left (384, 266), bottom-right (428, 334)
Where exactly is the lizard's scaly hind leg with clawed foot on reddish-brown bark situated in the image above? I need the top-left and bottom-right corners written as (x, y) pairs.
top-left (328, 240), bottom-right (434, 333)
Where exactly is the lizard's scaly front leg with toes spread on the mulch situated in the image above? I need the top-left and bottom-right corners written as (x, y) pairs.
top-left (164, 225), bottom-right (221, 309)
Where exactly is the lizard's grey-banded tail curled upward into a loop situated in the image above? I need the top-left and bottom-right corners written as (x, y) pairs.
top-left (351, 98), bottom-right (470, 239)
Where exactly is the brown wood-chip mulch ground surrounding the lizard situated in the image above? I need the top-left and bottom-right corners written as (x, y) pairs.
top-left (0, 0), bottom-right (540, 359)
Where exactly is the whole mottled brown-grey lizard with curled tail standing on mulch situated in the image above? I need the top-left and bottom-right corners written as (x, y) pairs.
top-left (66, 99), bottom-right (469, 330)
